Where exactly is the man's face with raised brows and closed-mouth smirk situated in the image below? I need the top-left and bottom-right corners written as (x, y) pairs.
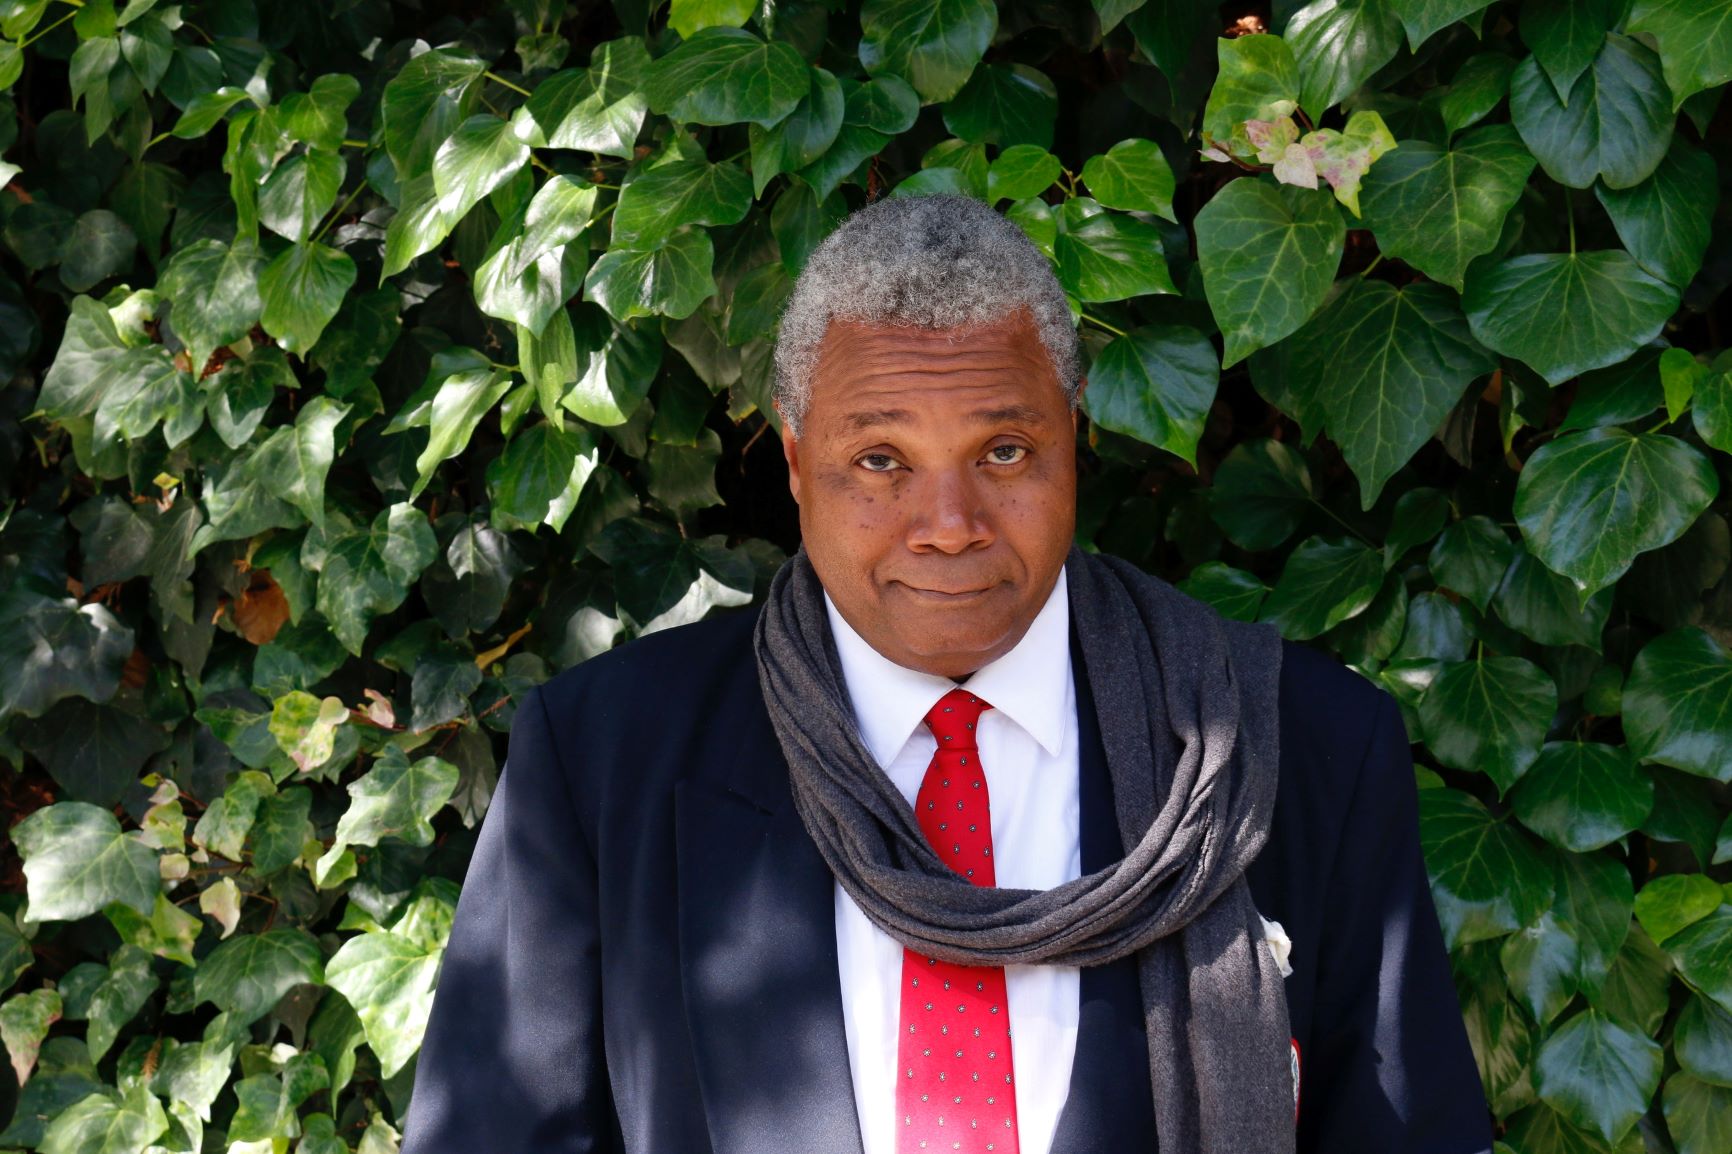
top-left (783, 312), bottom-right (1076, 677)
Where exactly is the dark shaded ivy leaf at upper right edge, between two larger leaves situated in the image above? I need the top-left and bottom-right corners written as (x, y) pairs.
top-left (1593, 137), bottom-right (1720, 289)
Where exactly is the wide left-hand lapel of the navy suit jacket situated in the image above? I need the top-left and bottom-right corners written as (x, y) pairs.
top-left (675, 700), bottom-right (861, 1154)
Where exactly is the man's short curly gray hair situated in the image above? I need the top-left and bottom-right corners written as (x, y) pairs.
top-left (774, 196), bottom-right (1079, 437)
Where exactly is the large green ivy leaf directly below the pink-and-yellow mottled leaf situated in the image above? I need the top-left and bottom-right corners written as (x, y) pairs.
top-left (1195, 177), bottom-right (1346, 369)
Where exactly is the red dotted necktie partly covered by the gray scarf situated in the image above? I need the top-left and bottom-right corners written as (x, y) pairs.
top-left (895, 690), bottom-right (1018, 1154)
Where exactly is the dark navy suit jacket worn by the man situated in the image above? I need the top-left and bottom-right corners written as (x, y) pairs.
top-left (404, 596), bottom-right (1491, 1154)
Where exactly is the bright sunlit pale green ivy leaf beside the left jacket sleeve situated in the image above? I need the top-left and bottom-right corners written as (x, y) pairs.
top-left (326, 928), bottom-right (439, 1078)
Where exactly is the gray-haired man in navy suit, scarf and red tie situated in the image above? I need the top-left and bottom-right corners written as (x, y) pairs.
top-left (404, 198), bottom-right (1491, 1154)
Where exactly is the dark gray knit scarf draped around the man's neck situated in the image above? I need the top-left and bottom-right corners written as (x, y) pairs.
top-left (755, 548), bottom-right (1294, 1154)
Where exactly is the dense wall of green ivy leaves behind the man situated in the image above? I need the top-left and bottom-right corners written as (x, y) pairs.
top-left (0, 0), bottom-right (1732, 1154)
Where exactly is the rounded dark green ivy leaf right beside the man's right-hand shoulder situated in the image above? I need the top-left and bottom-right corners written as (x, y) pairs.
top-left (1419, 657), bottom-right (1557, 790)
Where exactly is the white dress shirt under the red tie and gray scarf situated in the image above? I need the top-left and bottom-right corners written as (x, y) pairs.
top-left (824, 570), bottom-right (1083, 1154)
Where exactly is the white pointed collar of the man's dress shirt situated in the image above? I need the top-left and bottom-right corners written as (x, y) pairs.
top-left (824, 568), bottom-right (1072, 766)
